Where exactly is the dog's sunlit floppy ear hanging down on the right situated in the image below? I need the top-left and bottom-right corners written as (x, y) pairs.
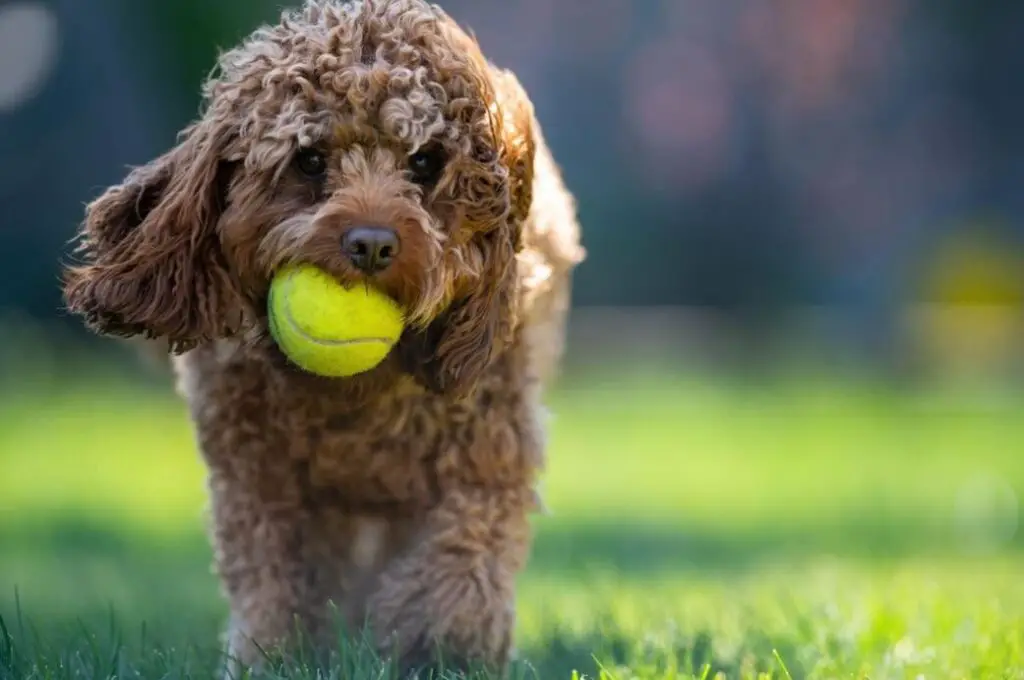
top-left (397, 69), bottom-right (535, 395)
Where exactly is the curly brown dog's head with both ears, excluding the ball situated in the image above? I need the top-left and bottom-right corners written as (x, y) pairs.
top-left (65, 0), bottom-right (534, 392)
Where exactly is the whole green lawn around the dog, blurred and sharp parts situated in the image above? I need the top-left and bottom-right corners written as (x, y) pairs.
top-left (0, 372), bottom-right (1024, 680)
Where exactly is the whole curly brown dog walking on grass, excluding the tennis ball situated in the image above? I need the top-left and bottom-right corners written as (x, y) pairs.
top-left (58, 0), bottom-right (584, 669)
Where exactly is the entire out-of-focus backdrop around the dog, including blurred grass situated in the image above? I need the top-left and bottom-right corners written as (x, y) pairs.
top-left (0, 0), bottom-right (1024, 675)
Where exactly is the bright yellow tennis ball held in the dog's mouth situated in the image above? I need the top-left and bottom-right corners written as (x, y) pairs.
top-left (267, 264), bottom-right (404, 378)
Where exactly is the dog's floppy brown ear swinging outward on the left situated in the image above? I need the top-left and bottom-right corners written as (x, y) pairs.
top-left (63, 120), bottom-right (244, 351)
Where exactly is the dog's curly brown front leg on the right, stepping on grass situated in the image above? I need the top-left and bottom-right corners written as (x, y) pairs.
top-left (368, 487), bottom-right (532, 673)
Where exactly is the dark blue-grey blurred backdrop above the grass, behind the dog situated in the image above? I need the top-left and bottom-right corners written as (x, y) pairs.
top-left (0, 0), bottom-right (1024, 377)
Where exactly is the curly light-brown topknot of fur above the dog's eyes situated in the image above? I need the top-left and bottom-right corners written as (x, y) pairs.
top-left (207, 0), bottom-right (512, 184)
